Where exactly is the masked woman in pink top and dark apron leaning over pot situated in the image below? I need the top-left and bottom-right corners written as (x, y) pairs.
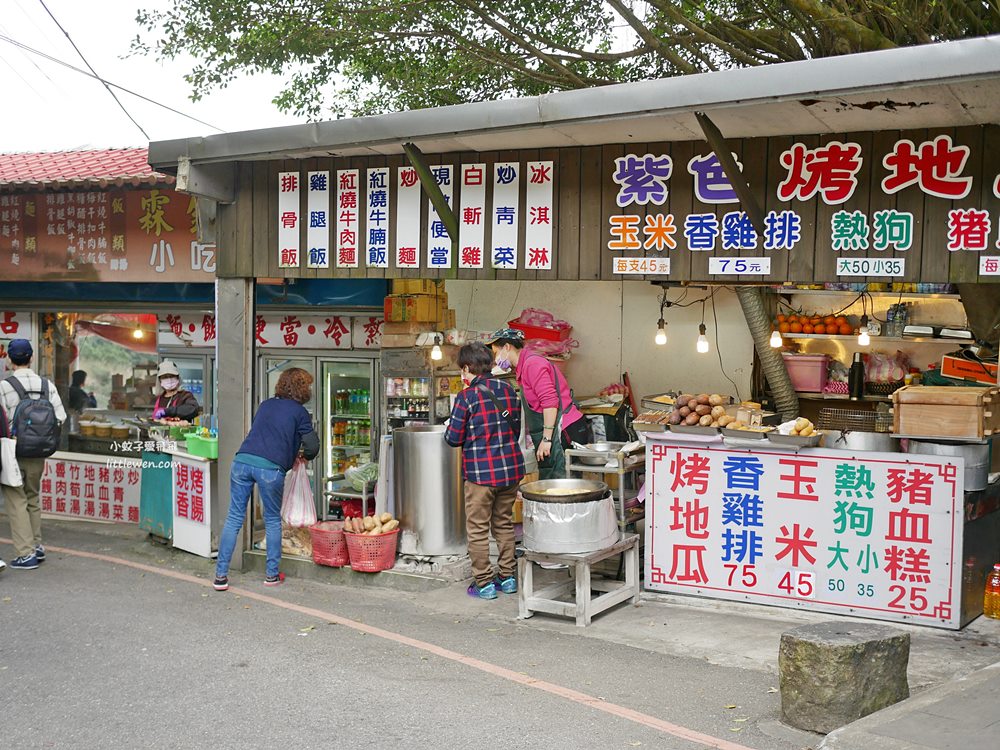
top-left (486, 328), bottom-right (594, 479)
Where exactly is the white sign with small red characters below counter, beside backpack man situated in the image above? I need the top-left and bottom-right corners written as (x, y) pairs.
top-left (38, 453), bottom-right (142, 524)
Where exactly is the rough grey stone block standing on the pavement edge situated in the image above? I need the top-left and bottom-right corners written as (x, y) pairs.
top-left (778, 622), bottom-right (910, 734)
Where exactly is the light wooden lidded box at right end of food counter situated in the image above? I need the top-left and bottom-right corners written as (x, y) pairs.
top-left (892, 385), bottom-right (1000, 440)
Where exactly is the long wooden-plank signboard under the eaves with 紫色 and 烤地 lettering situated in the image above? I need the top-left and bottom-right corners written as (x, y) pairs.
top-left (242, 125), bottom-right (1000, 283)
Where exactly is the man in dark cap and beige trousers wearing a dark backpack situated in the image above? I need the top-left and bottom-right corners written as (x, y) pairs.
top-left (0, 339), bottom-right (66, 570)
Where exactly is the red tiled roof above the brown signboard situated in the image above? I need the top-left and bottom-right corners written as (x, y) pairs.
top-left (0, 148), bottom-right (174, 190)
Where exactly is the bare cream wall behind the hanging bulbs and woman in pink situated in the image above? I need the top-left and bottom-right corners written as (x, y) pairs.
top-left (445, 280), bottom-right (753, 406)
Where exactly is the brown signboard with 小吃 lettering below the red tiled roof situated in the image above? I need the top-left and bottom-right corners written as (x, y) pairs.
top-left (0, 188), bottom-right (216, 282)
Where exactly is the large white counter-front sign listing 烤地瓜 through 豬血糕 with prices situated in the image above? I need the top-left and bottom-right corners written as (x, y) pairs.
top-left (645, 441), bottom-right (964, 629)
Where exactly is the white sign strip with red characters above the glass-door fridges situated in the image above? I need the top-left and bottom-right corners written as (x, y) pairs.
top-left (158, 313), bottom-right (383, 349)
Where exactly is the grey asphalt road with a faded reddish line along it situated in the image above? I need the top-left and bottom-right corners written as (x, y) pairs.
top-left (0, 527), bottom-right (805, 750)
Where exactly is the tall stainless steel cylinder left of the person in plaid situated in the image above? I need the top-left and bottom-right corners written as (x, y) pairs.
top-left (392, 425), bottom-right (467, 556)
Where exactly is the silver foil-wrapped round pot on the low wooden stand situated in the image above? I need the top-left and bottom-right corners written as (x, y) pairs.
top-left (522, 496), bottom-right (619, 554)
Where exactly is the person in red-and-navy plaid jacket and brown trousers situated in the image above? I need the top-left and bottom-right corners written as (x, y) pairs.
top-left (445, 342), bottom-right (524, 599)
